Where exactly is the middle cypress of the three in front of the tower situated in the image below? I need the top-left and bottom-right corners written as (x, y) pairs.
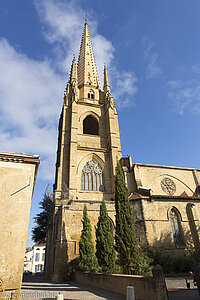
top-left (96, 200), bottom-right (116, 273)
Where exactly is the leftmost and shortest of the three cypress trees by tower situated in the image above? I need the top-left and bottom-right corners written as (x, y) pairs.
top-left (79, 205), bottom-right (98, 272)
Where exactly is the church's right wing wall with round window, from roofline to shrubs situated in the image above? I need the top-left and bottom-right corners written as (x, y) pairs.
top-left (122, 159), bottom-right (200, 255)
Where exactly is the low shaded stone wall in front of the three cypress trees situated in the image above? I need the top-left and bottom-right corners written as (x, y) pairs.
top-left (75, 265), bottom-right (168, 300)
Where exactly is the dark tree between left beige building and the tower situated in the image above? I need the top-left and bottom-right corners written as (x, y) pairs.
top-left (32, 187), bottom-right (53, 243)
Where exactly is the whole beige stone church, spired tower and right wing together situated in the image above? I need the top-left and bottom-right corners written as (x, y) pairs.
top-left (45, 21), bottom-right (200, 282)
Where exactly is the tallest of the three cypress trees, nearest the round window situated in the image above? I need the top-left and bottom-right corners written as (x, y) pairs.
top-left (115, 162), bottom-right (150, 275)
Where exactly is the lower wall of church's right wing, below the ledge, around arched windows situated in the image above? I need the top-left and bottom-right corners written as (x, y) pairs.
top-left (142, 199), bottom-right (200, 254)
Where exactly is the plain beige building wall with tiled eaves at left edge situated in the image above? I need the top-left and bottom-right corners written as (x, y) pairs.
top-left (0, 153), bottom-right (39, 290)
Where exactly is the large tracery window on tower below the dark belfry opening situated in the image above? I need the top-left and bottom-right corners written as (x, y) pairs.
top-left (81, 160), bottom-right (104, 191)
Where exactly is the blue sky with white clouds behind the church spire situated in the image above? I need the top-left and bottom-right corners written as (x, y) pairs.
top-left (0, 0), bottom-right (200, 245)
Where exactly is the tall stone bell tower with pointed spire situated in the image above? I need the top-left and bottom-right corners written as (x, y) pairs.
top-left (45, 21), bottom-right (122, 282)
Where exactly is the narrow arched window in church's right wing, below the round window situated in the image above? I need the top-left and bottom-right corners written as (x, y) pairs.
top-left (169, 208), bottom-right (185, 247)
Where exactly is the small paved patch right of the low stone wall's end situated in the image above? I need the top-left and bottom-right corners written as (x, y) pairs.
top-left (165, 277), bottom-right (200, 300)
